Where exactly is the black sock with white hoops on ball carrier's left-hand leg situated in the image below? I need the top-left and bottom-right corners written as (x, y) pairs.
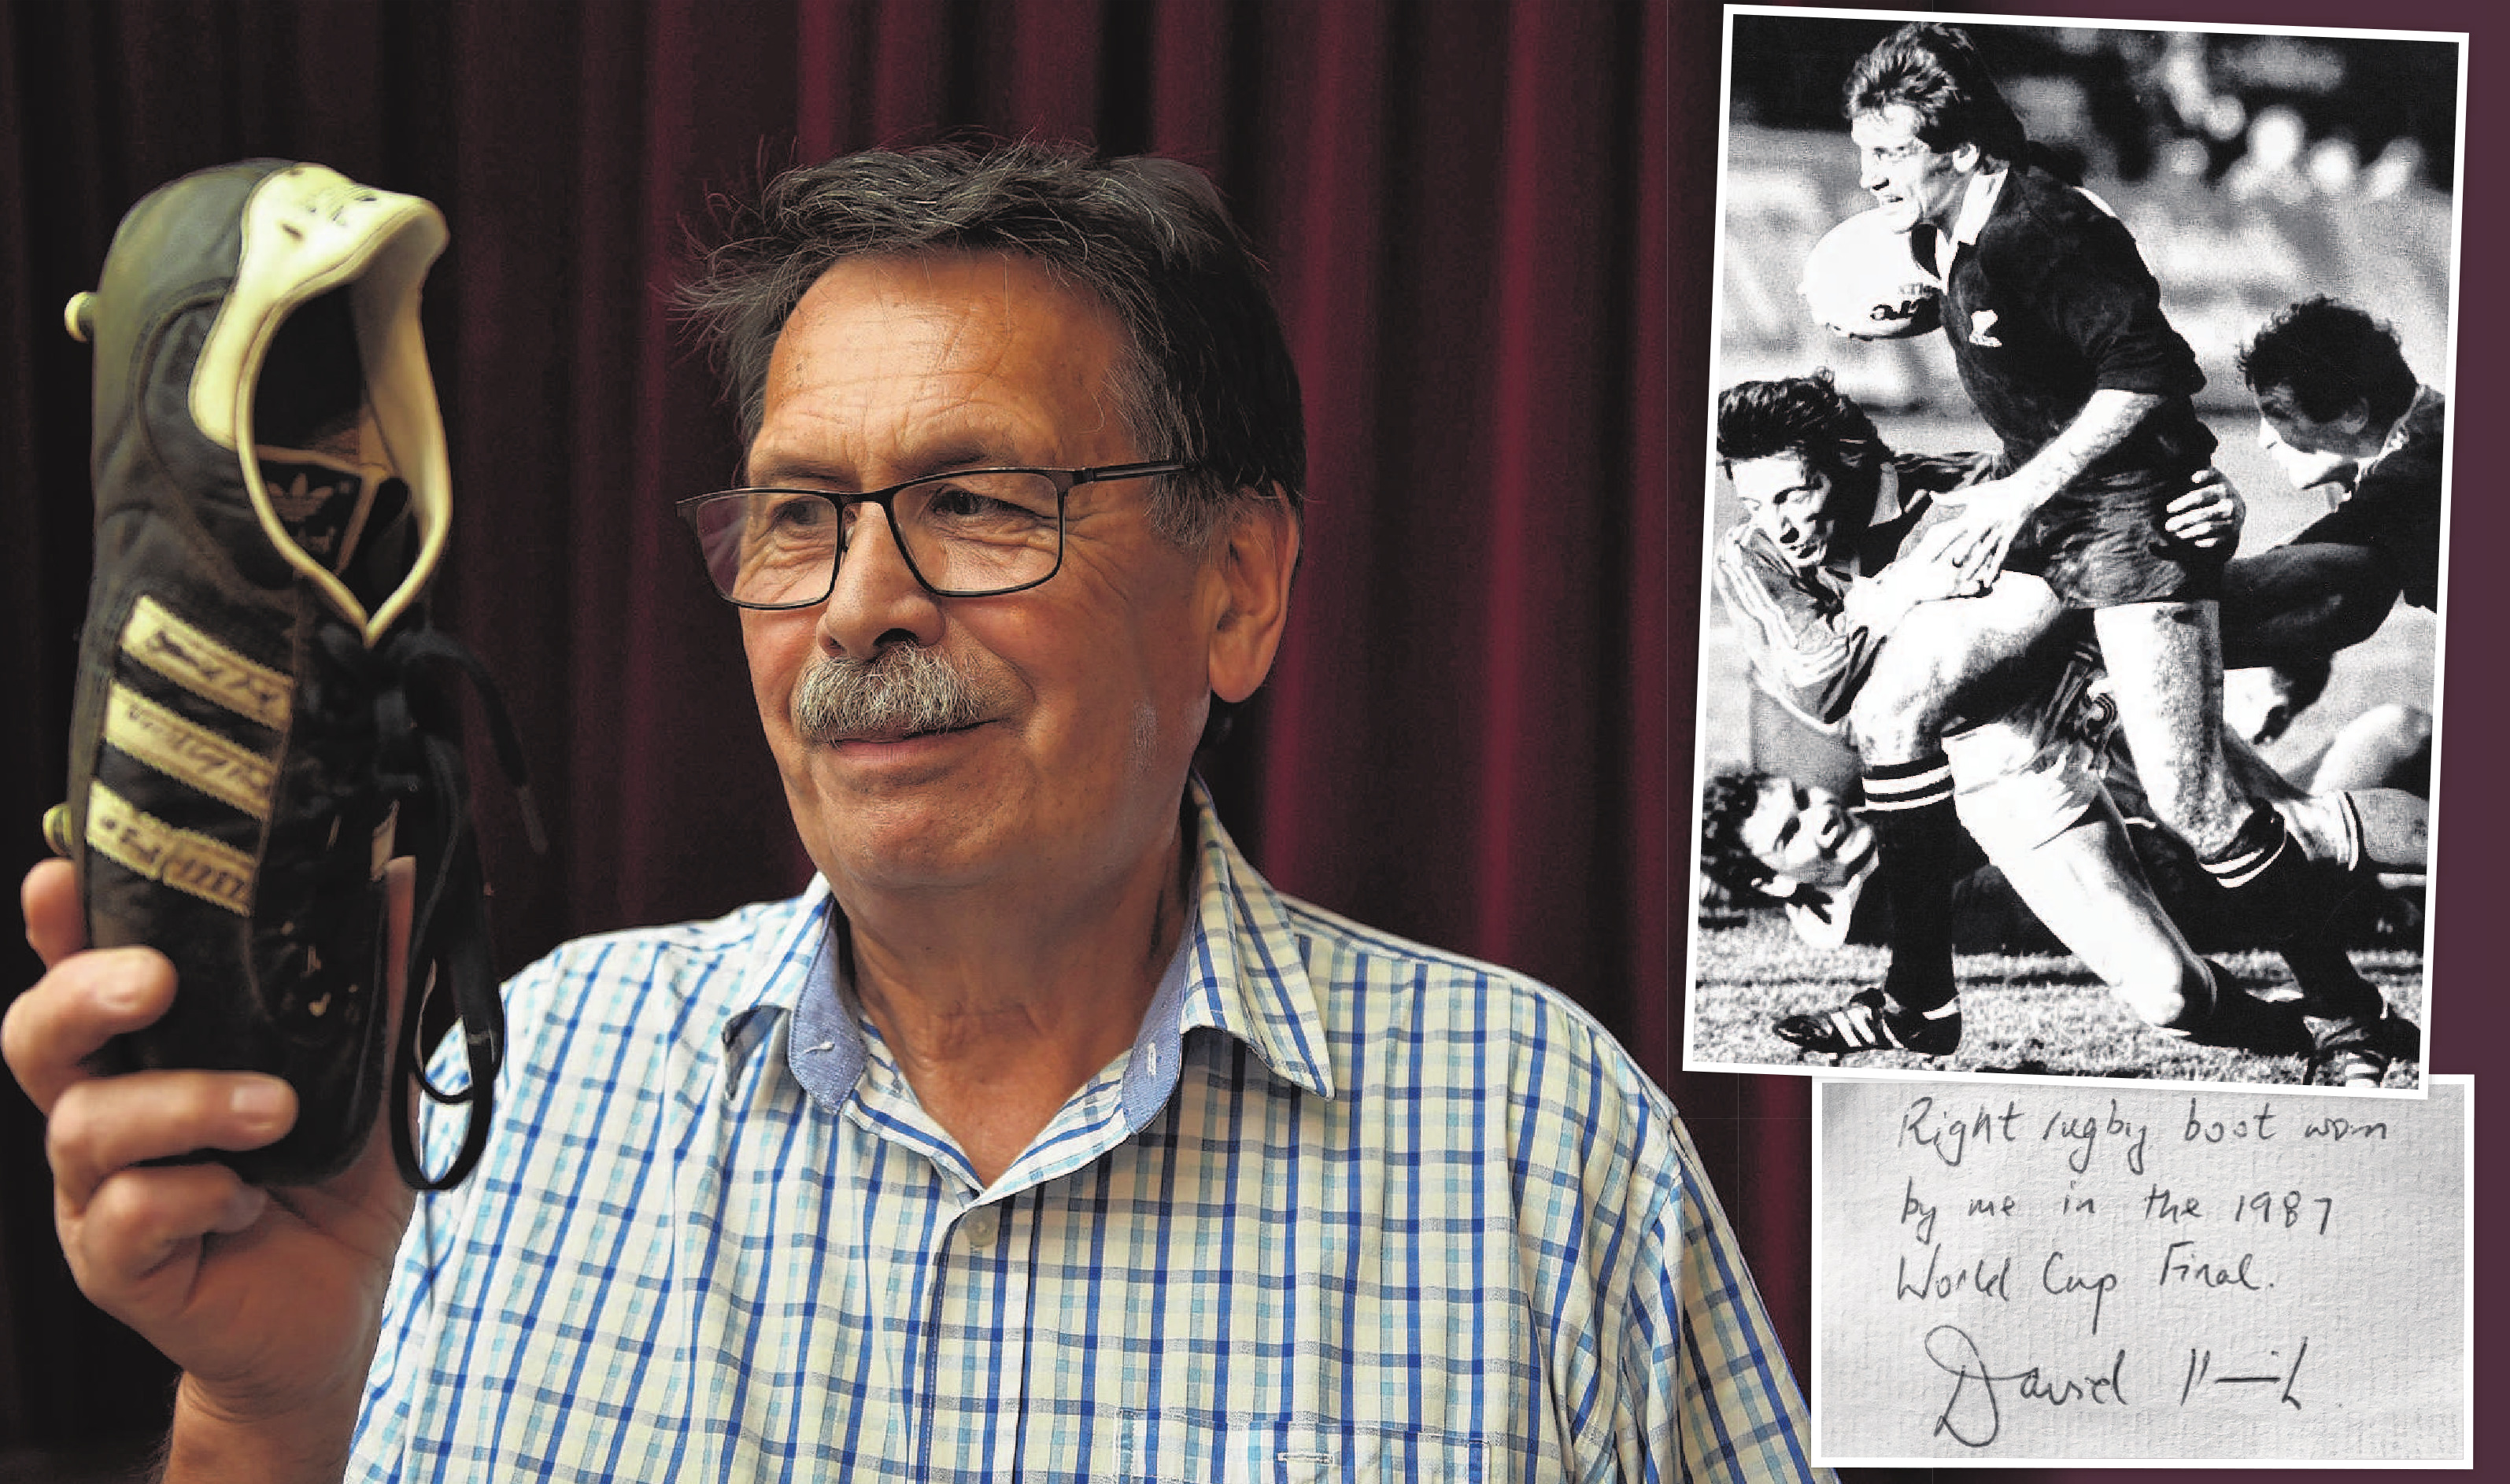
top-left (1865, 751), bottom-right (1961, 1020)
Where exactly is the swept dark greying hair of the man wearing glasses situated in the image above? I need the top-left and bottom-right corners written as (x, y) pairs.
top-left (678, 141), bottom-right (1307, 552)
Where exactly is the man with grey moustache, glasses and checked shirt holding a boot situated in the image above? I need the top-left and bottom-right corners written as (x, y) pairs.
top-left (8, 146), bottom-right (1809, 1479)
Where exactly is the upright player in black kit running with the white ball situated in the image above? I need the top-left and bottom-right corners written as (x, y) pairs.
top-left (1777, 23), bottom-right (2419, 1085)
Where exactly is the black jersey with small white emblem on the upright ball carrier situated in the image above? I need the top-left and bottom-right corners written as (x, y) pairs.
top-left (1943, 166), bottom-right (2214, 477)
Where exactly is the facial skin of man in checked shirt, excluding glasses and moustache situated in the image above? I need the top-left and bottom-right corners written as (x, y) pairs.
top-left (741, 253), bottom-right (1240, 899)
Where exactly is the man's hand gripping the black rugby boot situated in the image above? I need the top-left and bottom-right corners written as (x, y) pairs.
top-left (0, 862), bottom-right (412, 1479)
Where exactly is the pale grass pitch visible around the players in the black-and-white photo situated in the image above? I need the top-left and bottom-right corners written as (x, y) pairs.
top-left (1684, 417), bottom-right (2440, 1087)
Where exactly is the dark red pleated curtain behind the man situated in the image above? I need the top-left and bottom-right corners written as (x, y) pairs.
top-left (0, 0), bottom-right (1805, 1442)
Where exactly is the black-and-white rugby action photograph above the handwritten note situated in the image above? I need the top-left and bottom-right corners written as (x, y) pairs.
top-left (1684, 8), bottom-right (2465, 1095)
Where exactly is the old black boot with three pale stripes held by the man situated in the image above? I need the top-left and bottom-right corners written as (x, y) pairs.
top-left (45, 161), bottom-right (517, 1187)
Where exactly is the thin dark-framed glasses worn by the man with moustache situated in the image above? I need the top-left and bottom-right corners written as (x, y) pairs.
top-left (678, 462), bottom-right (1192, 607)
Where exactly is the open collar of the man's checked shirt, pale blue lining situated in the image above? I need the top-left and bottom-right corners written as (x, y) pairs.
top-left (723, 778), bottom-right (1336, 1128)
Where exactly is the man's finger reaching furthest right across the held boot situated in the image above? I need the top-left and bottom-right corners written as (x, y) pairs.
top-left (43, 1072), bottom-right (296, 1208)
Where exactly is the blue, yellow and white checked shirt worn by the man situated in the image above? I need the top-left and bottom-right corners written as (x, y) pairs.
top-left (349, 788), bottom-right (1812, 1484)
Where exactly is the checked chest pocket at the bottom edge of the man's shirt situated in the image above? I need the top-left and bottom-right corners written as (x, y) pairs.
top-left (1125, 1408), bottom-right (1484, 1484)
